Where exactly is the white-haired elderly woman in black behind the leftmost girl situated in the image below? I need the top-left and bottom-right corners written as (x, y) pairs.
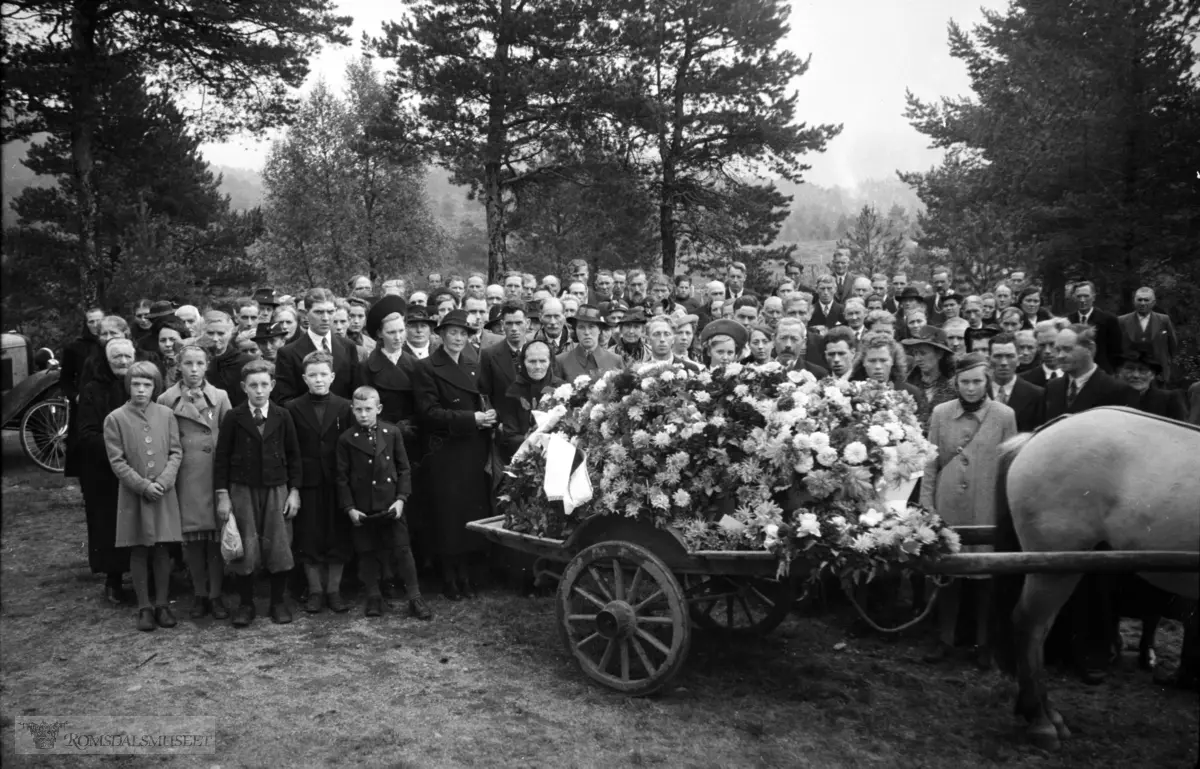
top-left (79, 340), bottom-right (134, 605)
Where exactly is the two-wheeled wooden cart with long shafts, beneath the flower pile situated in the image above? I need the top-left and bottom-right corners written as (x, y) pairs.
top-left (467, 516), bottom-right (1200, 696)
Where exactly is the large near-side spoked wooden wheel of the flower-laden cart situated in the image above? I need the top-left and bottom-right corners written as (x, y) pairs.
top-left (557, 542), bottom-right (691, 697)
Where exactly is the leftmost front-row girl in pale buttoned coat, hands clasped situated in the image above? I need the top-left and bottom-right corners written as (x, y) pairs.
top-left (104, 361), bottom-right (184, 631)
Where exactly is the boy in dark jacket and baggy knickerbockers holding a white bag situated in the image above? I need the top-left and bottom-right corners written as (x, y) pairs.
top-left (212, 360), bottom-right (302, 627)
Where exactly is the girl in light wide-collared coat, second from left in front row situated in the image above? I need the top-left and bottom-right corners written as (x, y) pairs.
top-left (158, 344), bottom-right (233, 619)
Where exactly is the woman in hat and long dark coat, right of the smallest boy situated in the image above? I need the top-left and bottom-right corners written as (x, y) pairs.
top-left (413, 310), bottom-right (496, 601)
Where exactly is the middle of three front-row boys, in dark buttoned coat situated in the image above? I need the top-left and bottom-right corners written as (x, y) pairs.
top-left (284, 352), bottom-right (354, 614)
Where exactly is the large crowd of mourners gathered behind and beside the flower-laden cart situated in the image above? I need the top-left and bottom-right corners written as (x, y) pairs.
top-left (51, 248), bottom-right (1200, 680)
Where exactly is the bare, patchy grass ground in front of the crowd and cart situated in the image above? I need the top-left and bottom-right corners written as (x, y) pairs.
top-left (0, 443), bottom-right (1200, 769)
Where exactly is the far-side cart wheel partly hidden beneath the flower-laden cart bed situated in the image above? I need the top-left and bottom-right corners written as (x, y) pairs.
top-left (684, 575), bottom-right (796, 636)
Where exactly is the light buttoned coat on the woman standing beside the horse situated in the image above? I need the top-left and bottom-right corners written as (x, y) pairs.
top-left (920, 399), bottom-right (1016, 525)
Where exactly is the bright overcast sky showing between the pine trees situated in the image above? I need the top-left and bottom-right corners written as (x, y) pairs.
top-left (204, 0), bottom-right (1006, 187)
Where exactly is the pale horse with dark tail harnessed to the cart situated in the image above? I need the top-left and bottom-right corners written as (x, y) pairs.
top-left (992, 407), bottom-right (1200, 750)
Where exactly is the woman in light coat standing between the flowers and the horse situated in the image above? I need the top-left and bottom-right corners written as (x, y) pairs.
top-left (920, 353), bottom-right (1016, 667)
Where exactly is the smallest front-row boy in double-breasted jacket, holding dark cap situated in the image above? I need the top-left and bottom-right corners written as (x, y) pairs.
top-left (337, 386), bottom-right (433, 619)
